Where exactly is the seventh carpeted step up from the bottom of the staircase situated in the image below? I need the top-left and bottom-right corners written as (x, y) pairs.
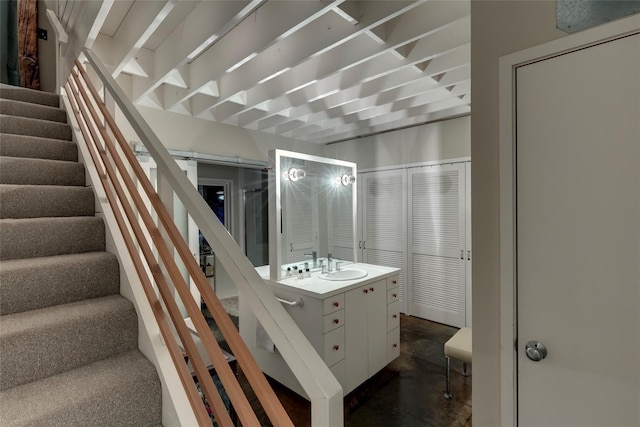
top-left (0, 133), bottom-right (78, 162)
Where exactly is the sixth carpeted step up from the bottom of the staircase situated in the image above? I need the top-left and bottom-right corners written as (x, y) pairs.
top-left (0, 156), bottom-right (86, 186)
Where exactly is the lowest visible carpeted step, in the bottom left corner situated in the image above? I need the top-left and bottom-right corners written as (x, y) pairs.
top-left (0, 351), bottom-right (162, 427)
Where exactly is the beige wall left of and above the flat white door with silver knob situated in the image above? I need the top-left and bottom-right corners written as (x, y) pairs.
top-left (471, 0), bottom-right (567, 426)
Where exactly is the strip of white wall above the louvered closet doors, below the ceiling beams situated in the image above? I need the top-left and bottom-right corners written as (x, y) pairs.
top-left (325, 116), bottom-right (471, 171)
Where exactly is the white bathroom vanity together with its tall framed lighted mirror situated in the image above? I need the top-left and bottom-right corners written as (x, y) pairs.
top-left (239, 150), bottom-right (400, 399)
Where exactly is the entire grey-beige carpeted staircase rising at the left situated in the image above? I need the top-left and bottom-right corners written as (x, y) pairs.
top-left (0, 85), bottom-right (162, 427)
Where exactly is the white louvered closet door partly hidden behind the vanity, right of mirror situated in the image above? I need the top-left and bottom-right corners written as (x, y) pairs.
top-left (358, 169), bottom-right (408, 313)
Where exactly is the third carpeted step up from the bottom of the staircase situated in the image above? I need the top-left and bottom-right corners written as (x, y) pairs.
top-left (0, 252), bottom-right (120, 315)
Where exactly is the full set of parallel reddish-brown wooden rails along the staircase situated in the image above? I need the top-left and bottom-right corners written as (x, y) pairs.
top-left (67, 57), bottom-right (293, 426)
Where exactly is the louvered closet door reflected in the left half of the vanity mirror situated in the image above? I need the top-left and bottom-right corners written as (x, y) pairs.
top-left (282, 175), bottom-right (318, 263)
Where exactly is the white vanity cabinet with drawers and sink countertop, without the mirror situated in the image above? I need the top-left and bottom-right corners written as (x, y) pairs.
top-left (240, 263), bottom-right (400, 398)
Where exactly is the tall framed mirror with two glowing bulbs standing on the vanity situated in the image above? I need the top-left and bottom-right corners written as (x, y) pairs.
top-left (269, 150), bottom-right (357, 280)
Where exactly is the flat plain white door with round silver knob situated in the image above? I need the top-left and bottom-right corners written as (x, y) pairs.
top-left (515, 34), bottom-right (640, 426)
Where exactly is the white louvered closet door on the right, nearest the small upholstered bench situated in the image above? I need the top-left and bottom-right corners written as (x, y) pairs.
top-left (408, 163), bottom-right (466, 327)
